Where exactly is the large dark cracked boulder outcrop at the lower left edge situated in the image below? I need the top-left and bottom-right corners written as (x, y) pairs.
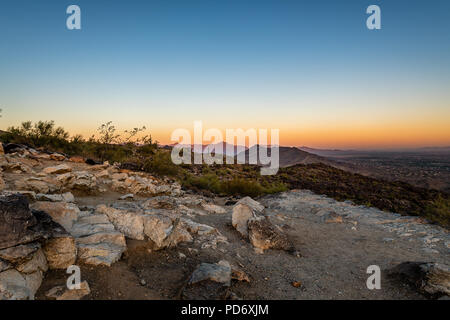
top-left (0, 194), bottom-right (72, 300)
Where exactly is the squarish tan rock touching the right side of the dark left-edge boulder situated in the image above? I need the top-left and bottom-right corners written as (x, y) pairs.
top-left (43, 235), bottom-right (77, 269)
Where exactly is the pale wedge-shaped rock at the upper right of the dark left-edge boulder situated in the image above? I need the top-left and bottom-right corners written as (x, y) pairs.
top-left (31, 201), bottom-right (80, 232)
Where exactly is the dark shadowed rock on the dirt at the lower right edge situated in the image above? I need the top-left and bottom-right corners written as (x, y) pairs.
top-left (389, 262), bottom-right (450, 297)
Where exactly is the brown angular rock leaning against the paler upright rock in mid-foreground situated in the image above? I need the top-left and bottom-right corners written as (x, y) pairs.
top-left (248, 217), bottom-right (294, 251)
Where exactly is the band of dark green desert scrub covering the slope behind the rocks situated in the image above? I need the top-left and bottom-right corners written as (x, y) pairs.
top-left (0, 121), bottom-right (450, 227)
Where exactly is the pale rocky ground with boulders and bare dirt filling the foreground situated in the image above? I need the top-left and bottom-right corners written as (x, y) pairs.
top-left (0, 148), bottom-right (450, 300)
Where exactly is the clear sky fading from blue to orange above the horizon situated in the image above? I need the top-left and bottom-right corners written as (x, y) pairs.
top-left (0, 0), bottom-right (450, 148)
